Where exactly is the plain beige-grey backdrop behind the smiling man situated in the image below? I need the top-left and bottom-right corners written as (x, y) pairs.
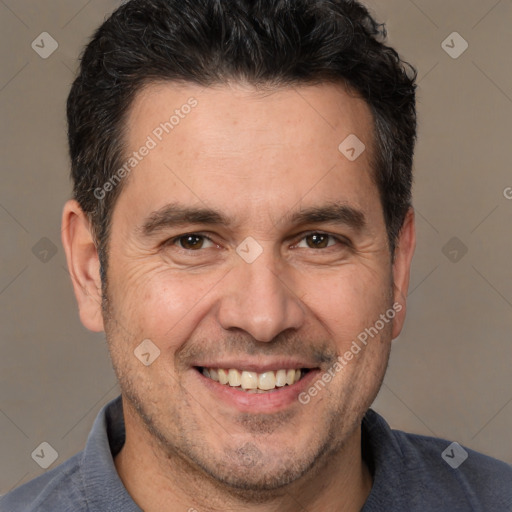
top-left (0, 0), bottom-right (512, 494)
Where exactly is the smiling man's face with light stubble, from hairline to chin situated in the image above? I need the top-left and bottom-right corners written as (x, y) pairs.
top-left (99, 84), bottom-right (401, 490)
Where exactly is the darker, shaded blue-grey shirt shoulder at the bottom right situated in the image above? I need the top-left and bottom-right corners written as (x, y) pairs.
top-left (366, 411), bottom-right (512, 512)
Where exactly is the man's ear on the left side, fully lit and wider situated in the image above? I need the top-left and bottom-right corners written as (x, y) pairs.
top-left (62, 200), bottom-right (104, 332)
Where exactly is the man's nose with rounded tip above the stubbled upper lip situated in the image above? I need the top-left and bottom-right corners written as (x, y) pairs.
top-left (218, 254), bottom-right (305, 342)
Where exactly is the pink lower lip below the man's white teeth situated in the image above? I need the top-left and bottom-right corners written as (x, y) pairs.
top-left (194, 368), bottom-right (320, 413)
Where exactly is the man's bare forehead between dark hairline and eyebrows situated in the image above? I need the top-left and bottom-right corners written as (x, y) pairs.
top-left (115, 82), bottom-right (378, 230)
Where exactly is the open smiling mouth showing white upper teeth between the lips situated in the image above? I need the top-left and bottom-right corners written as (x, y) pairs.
top-left (195, 366), bottom-right (311, 394)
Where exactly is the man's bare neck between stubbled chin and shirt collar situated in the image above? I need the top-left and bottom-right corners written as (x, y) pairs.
top-left (114, 403), bottom-right (372, 512)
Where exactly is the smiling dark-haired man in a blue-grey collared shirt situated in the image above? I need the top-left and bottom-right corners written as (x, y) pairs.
top-left (0, 0), bottom-right (512, 512)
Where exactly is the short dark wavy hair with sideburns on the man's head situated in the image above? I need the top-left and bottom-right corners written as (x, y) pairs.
top-left (67, 0), bottom-right (417, 280)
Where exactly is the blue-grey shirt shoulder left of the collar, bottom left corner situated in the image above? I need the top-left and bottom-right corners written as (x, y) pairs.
top-left (0, 452), bottom-right (87, 512)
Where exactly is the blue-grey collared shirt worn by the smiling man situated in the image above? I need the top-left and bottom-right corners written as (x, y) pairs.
top-left (0, 397), bottom-right (512, 512)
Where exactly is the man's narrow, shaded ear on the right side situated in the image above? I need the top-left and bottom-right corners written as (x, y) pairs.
top-left (393, 208), bottom-right (416, 339)
